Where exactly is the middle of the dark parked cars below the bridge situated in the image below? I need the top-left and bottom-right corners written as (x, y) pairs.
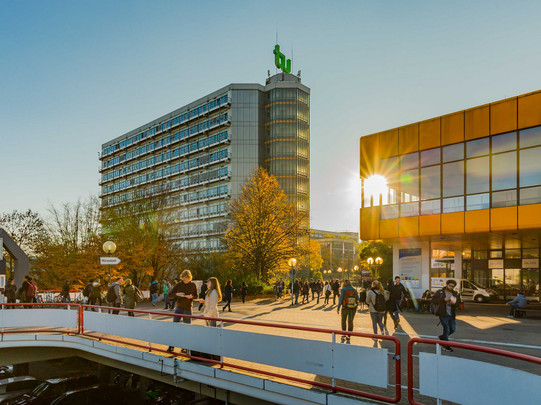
top-left (5, 374), bottom-right (99, 405)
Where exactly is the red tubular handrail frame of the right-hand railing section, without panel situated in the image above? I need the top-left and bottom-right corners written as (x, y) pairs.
top-left (408, 338), bottom-right (541, 405)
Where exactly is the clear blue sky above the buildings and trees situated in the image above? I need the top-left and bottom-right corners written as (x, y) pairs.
top-left (0, 0), bottom-right (541, 231)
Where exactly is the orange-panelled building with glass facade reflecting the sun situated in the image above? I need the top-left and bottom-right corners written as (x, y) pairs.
top-left (361, 92), bottom-right (541, 299)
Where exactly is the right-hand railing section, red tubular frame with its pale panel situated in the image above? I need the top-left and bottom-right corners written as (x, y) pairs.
top-left (408, 338), bottom-right (541, 405)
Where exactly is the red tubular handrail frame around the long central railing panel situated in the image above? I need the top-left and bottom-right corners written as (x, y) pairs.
top-left (80, 305), bottom-right (402, 403)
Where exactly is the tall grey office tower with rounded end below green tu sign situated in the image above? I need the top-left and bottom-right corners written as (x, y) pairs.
top-left (100, 73), bottom-right (310, 251)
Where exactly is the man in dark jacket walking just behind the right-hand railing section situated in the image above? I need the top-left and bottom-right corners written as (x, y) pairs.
top-left (430, 280), bottom-right (460, 352)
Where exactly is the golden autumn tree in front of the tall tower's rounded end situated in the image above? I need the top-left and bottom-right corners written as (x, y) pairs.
top-left (225, 169), bottom-right (308, 281)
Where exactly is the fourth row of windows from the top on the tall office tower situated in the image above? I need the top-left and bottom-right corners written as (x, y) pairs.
top-left (102, 148), bottom-right (229, 195)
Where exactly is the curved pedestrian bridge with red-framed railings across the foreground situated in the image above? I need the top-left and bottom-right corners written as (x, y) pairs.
top-left (0, 304), bottom-right (541, 405)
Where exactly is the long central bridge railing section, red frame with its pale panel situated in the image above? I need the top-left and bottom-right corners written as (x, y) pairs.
top-left (81, 305), bottom-right (401, 403)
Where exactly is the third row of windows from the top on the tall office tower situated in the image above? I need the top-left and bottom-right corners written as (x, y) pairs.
top-left (102, 131), bottom-right (228, 182)
